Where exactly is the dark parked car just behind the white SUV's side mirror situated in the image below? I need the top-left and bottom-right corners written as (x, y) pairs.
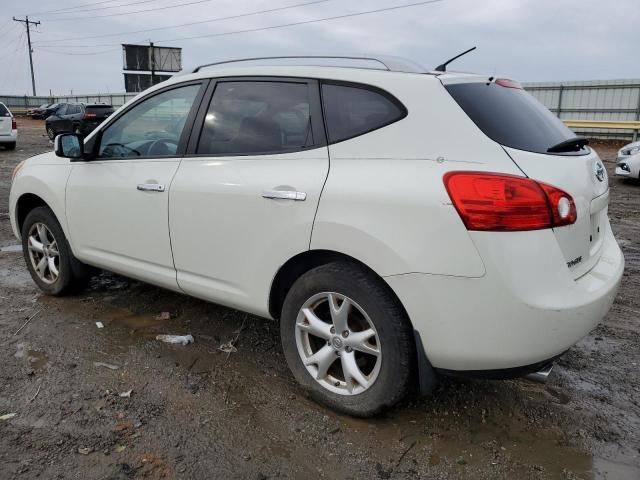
top-left (45, 103), bottom-right (114, 140)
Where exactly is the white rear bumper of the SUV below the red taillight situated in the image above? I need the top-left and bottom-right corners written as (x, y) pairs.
top-left (385, 223), bottom-right (624, 373)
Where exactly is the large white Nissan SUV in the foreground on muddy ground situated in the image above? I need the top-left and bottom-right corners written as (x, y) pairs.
top-left (10, 57), bottom-right (624, 416)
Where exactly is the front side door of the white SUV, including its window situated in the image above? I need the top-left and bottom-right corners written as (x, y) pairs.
top-left (67, 83), bottom-right (203, 289)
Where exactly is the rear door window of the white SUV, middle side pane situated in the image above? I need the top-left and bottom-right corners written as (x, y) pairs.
top-left (197, 82), bottom-right (314, 155)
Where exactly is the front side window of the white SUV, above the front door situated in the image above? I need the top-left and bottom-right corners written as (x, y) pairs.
top-left (98, 85), bottom-right (200, 158)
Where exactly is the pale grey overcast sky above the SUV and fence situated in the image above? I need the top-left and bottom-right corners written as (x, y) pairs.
top-left (0, 0), bottom-right (640, 95)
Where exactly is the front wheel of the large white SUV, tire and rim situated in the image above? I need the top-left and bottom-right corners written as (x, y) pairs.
top-left (21, 207), bottom-right (93, 297)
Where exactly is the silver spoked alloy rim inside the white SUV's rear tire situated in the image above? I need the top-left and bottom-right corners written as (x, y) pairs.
top-left (295, 292), bottom-right (382, 395)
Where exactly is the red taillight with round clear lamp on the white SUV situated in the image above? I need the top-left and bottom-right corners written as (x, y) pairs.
top-left (444, 172), bottom-right (577, 232)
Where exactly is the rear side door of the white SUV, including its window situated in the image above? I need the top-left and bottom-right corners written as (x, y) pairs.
top-left (170, 79), bottom-right (329, 315)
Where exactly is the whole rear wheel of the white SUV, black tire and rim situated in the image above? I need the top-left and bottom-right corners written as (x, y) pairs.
top-left (280, 262), bottom-right (416, 417)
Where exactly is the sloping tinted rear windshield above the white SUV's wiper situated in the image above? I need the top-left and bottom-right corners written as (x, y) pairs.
top-left (445, 83), bottom-right (587, 155)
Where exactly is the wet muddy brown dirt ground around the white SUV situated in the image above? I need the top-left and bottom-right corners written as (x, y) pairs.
top-left (0, 120), bottom-right (640, 480)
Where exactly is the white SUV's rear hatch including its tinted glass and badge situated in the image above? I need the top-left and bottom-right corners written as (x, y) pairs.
top-left (441, 77), bottom-right (609, 278)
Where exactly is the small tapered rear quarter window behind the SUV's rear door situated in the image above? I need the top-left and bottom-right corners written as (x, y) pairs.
top-left (322, 84), bottom-right (406, 143)
